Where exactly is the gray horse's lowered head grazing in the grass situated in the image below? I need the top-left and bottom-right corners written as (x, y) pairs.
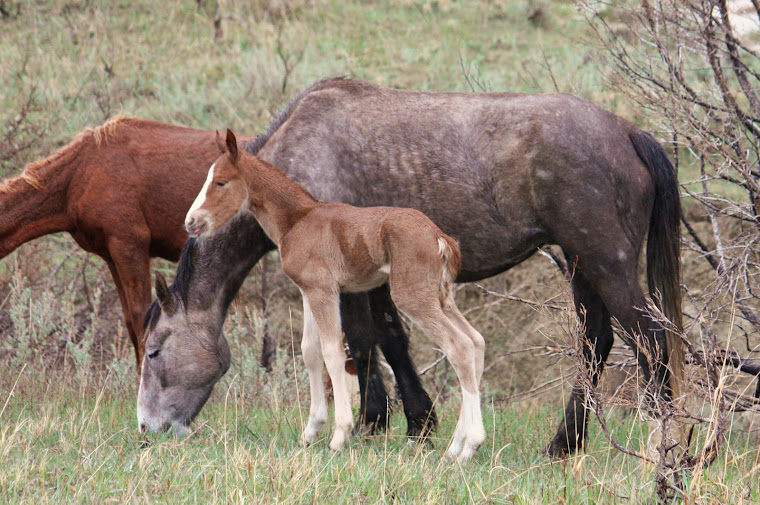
top-left (137, 274), bottom-right (230, 434)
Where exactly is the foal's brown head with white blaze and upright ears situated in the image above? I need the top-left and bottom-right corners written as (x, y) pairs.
top-left (185, 130), bottom-right (248, 236)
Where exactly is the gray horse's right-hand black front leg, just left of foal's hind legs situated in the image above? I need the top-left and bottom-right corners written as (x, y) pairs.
top-left (368, 284), bottom-right (438, 440)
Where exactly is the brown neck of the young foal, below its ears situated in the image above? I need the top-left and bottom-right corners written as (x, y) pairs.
top-left (241, 155), bottom-right (319, 247)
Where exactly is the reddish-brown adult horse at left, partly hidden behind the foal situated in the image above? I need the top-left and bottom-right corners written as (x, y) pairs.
top-left (0, 117), bottom-right (250, 370)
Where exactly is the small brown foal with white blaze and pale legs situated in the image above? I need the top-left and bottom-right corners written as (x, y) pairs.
top-left (185, 130), bottom-right (485, 460)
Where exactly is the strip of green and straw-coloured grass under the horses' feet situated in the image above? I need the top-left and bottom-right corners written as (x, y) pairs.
top-left (0, 370), bottom-right (760, 503)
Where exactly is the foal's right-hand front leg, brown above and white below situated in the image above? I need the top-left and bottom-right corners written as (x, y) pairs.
top-left (305, 290), bottom-right (354, 451)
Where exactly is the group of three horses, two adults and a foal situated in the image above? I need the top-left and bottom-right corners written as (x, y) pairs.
top-left (0, 78), bottom-right (683, 459)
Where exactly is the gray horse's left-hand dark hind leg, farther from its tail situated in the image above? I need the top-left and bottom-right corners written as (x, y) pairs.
top-left (546, 268), bottom-right (614, 457)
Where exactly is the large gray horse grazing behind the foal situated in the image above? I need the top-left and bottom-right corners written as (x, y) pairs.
top-left (138, 79), bottom-right (683, 455)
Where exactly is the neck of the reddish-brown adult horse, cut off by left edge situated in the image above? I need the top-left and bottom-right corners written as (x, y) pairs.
top-left (0, 171), bottom-right (73, 258)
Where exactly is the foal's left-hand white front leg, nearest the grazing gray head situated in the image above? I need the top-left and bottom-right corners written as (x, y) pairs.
top-left (301, 293), bottom-right (327, 445)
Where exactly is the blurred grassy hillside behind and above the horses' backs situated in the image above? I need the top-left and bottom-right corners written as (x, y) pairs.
top-left (0, 0), bottom-right (614, 165)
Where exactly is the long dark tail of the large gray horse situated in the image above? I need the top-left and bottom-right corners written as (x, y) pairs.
top-left (630, 131), bottom-right (685, 398)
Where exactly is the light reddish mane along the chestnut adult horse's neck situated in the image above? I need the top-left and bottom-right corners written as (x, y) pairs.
top-left (0, 115), bottom-right (132, 193)
